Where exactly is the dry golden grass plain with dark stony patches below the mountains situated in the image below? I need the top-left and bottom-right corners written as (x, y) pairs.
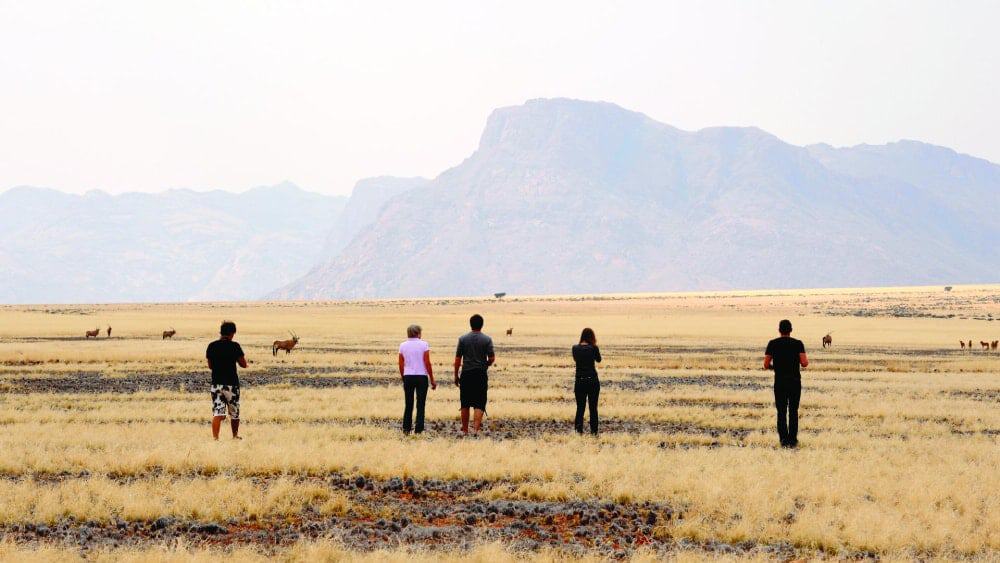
top-left (0, 286), bottom-right (1000, 561)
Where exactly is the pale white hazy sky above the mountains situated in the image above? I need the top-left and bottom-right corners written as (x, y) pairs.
top-left (0, 0), bottom-right (1000, 193)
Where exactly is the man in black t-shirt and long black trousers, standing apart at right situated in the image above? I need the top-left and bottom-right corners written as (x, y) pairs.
top-left (764, 319), bottom-right (809, 448)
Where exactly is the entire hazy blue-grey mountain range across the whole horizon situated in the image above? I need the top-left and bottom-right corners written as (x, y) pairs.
top-left (0, 99), bottom-right (1000, 303)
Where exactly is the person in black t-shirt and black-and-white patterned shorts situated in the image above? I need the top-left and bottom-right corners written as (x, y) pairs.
top-left (205, 321), bottom-right (247, 440)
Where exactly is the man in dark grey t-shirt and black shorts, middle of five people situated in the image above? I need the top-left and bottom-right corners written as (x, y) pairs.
top-left (455, 315), bottom-right (496, 434)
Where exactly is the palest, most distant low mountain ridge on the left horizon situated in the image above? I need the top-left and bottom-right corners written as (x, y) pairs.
top-left (0, 183), bottom-right (345, 303)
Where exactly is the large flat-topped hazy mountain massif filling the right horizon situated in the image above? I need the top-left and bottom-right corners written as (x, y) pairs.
top-left (270, 99), bottom-right (1000, 299)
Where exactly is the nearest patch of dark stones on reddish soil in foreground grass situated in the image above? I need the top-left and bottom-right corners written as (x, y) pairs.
top-left (0, 475), bottom-right (828, 559)
